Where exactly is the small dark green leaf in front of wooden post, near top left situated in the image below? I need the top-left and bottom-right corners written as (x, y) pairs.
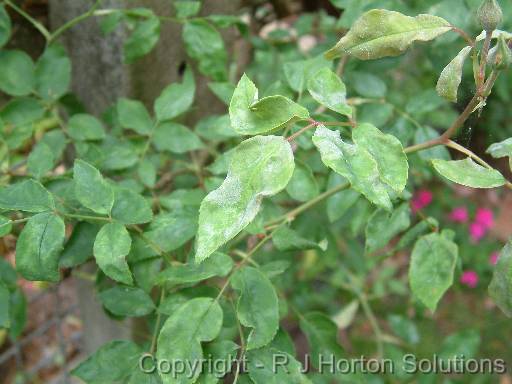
top-left (124, 14), bottom-right (160, 63)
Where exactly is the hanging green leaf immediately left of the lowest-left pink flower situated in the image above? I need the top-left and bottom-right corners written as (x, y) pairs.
top-left (409, 233), bottom-right (458, 311)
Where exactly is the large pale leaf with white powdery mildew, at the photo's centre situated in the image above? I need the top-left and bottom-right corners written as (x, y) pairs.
top-left (195, 136), bottom-right (295, 261)
